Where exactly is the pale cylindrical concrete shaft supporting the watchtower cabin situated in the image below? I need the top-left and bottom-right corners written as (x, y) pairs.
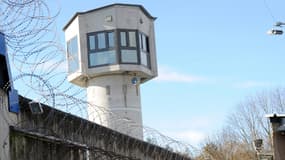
top-left (87, 74), bottom-right (143, 139)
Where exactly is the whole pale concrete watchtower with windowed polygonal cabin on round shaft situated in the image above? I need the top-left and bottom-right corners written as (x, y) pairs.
top-left (63, 4), bottom-right (157, 139)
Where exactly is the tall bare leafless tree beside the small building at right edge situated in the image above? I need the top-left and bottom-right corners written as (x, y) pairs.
top-left (228, 88), bottom-right (285, 151)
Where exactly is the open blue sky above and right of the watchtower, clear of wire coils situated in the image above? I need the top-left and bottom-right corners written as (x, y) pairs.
top-left (16, 0), bottom-right (285, 145)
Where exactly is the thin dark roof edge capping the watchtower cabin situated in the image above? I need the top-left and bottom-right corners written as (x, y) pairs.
top-left (63, 3), bottom-right (156, 30)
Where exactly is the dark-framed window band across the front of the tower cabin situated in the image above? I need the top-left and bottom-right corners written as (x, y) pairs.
top-left (87, 29), bottom-right (150, 68)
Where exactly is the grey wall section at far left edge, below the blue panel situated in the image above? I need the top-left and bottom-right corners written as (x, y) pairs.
top-left (0, 89), bottom-right (17, 160)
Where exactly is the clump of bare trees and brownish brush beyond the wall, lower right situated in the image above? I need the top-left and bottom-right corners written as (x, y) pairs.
top-left (197, 88), bottom-right (285, 160)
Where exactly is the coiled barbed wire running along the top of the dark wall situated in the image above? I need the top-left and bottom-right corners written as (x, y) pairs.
top-left (0, 0), bottom-right (197, 159)
